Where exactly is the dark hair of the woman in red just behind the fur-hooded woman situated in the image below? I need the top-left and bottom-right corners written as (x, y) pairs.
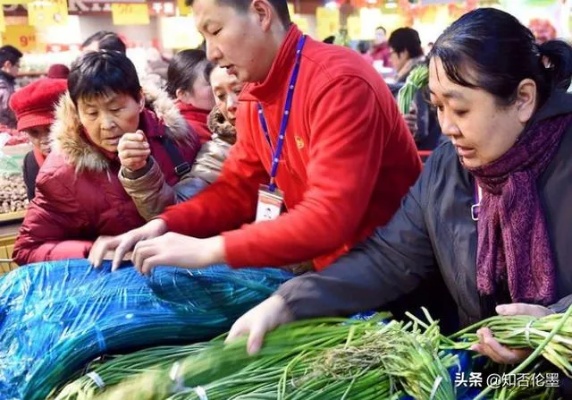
top-left (165, 49), bottom-right (212, 98)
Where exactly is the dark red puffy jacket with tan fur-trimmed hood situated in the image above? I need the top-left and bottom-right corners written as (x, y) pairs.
top-left (13, 90), bottom-right (199, 265)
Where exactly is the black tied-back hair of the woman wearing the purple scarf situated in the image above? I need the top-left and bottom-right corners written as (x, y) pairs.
top-left (428, 8), bottom-right (572, 106)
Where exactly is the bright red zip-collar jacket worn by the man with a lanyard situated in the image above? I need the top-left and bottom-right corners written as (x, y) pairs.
top-left (161, 26), bottom-right (421, 269)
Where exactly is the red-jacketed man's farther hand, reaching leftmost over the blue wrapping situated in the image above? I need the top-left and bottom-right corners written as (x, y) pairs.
top-left (88, 219), bottom-right (167, 271)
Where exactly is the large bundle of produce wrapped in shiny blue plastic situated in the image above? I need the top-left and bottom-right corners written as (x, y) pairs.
top-left (0, 259), bottom-right (293, 400)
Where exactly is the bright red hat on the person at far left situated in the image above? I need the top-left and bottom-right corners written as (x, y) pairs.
top-left (10, 78), bottom-right (68, 131)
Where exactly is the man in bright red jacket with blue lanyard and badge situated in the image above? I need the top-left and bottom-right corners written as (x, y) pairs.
top-left (90, 0), bottom-right (421, 273)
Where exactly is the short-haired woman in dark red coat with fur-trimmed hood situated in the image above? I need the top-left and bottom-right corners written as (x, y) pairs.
top-left (13, 51), bottom-right (199, 265)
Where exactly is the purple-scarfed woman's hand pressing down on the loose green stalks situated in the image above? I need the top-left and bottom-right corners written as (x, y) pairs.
top-left (226, 295), bottom-right (294, 355)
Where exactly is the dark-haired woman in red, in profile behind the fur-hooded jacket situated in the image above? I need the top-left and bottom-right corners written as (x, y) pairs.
top-left (166, 49), bottom-right (215, 144)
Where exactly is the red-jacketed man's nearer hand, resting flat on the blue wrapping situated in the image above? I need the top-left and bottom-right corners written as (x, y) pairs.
top-left (132, 232), bottom-right (225, 275)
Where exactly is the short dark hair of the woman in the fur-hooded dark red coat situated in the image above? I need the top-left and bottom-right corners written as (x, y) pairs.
top-left (68, 50), bottom-right (141, 106)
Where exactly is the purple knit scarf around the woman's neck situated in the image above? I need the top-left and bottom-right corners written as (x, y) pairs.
top-left (470, 114), bottom-right (572, 305)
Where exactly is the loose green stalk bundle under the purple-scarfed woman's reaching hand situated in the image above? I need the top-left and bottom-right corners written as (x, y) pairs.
top-left (82, 315), bottom-right (457, 400)
